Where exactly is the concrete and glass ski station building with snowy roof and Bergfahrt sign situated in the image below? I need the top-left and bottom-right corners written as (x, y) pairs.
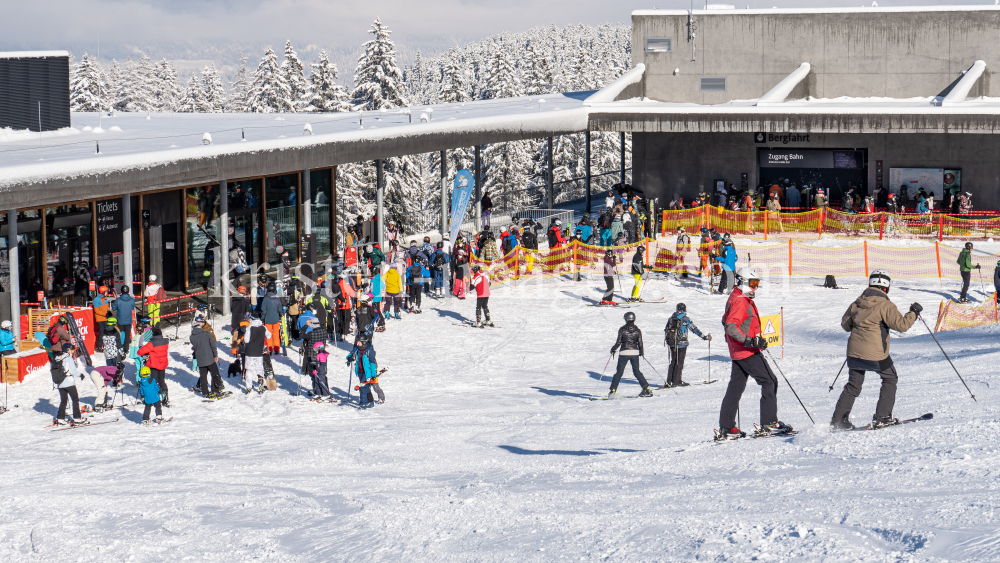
top-left (0, 6), bottom-right (1000, 338)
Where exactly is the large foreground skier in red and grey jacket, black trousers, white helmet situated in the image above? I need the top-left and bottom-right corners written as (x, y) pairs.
top-left (716, 267), bottom-right (792, 440)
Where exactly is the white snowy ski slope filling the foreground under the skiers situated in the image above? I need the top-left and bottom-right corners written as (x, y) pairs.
top-left (0, 270), bottom-right (1000, 562)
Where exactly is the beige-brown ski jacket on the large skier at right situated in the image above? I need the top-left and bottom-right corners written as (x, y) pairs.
top-left (840, 288), bottom-right (917, 362)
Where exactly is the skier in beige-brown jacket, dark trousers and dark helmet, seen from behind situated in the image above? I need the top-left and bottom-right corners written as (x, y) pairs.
top-left (830, 269), bottom-right (923, 430)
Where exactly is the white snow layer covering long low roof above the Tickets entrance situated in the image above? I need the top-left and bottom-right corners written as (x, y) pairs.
top-left (0, 92), bottom-right (592, 189)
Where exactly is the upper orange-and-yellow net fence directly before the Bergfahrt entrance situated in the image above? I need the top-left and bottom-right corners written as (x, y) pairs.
top-left (660, 205), bottom-right (1000, 241)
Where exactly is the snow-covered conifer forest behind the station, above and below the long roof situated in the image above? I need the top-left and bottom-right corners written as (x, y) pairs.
top-left (70, 18), bottom-right (631, 233)
